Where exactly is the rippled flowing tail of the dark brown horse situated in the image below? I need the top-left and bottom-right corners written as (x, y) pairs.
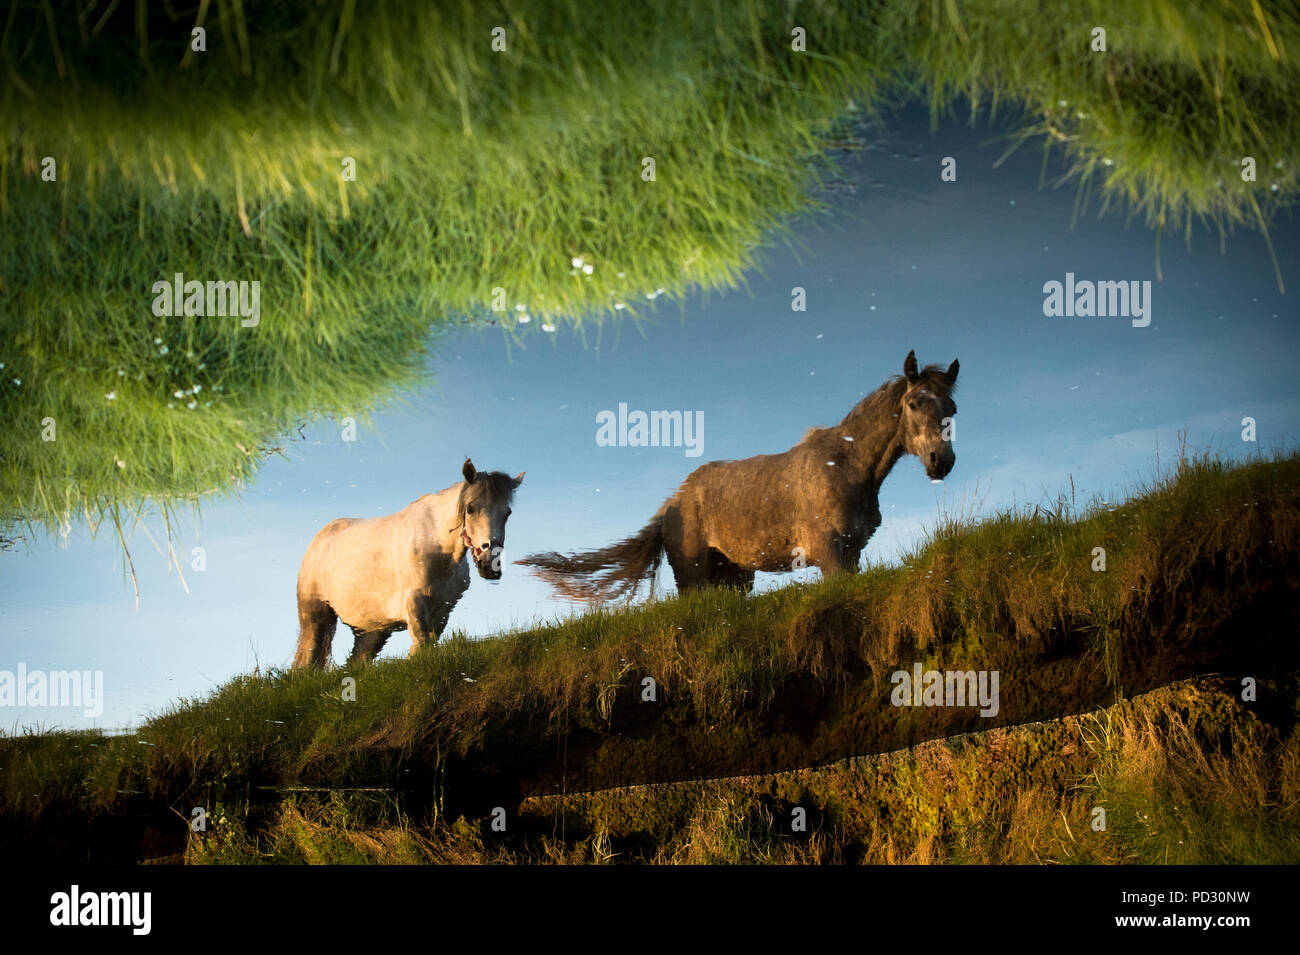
top-left (515, 503), bottom-right (668, 602)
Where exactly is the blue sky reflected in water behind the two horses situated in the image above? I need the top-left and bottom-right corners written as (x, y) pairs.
top-left (0, 109), bottom-right (1300, 732)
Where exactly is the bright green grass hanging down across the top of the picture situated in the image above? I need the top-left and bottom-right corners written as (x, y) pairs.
top-left (0, 0), bottom-right (1300, 548)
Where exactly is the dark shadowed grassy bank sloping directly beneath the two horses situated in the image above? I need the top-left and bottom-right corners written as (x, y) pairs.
top-left (0, 456), bottom-right (1300, 858)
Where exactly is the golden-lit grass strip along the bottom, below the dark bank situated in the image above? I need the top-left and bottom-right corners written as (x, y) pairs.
top-left (189, 677), bottom-right (1300, 865)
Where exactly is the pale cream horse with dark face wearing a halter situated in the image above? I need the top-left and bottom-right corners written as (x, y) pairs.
top-left (294, 457), bottom-right (524, 669)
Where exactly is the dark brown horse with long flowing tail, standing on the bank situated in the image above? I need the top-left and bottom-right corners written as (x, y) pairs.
top-left (515, 351), bottom-right (959, 602)
